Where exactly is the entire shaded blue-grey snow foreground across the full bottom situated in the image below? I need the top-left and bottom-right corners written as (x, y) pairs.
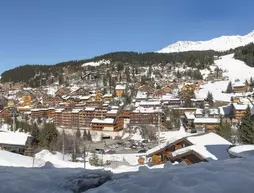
top-left (0, 148), bottom-right (254, 193)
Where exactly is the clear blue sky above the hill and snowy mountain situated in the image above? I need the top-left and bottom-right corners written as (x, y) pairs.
top-left (0, 0), bottom-right (254, 73)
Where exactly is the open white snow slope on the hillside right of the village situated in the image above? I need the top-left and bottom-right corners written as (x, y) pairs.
top-left (195, 54), bottom-right (254, 102)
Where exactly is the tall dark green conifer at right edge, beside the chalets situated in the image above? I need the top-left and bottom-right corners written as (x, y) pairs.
top-left (239, 107), bottom-right (254, 144)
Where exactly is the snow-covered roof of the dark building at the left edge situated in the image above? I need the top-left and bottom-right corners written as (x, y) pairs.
top-left (0, 131), bottom-right (30, 146)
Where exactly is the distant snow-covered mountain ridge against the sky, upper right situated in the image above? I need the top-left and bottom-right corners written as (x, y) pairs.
top-left (158, 31), bottom-right (254, 53)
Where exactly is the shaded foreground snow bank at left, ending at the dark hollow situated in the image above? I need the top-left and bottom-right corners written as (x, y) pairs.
top-left (0, 167), bottom-right (112, 193)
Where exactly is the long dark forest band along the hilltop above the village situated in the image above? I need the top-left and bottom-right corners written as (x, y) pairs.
top-left (1, 51), bottom-right (216, 87)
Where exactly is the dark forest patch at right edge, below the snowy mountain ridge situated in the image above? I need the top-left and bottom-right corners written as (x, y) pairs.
top-left (235, 43), bottom-right (254, 67)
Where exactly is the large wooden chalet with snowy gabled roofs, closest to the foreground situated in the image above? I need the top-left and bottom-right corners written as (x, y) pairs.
top-left (147, 133), bottom-right (232, 165)
